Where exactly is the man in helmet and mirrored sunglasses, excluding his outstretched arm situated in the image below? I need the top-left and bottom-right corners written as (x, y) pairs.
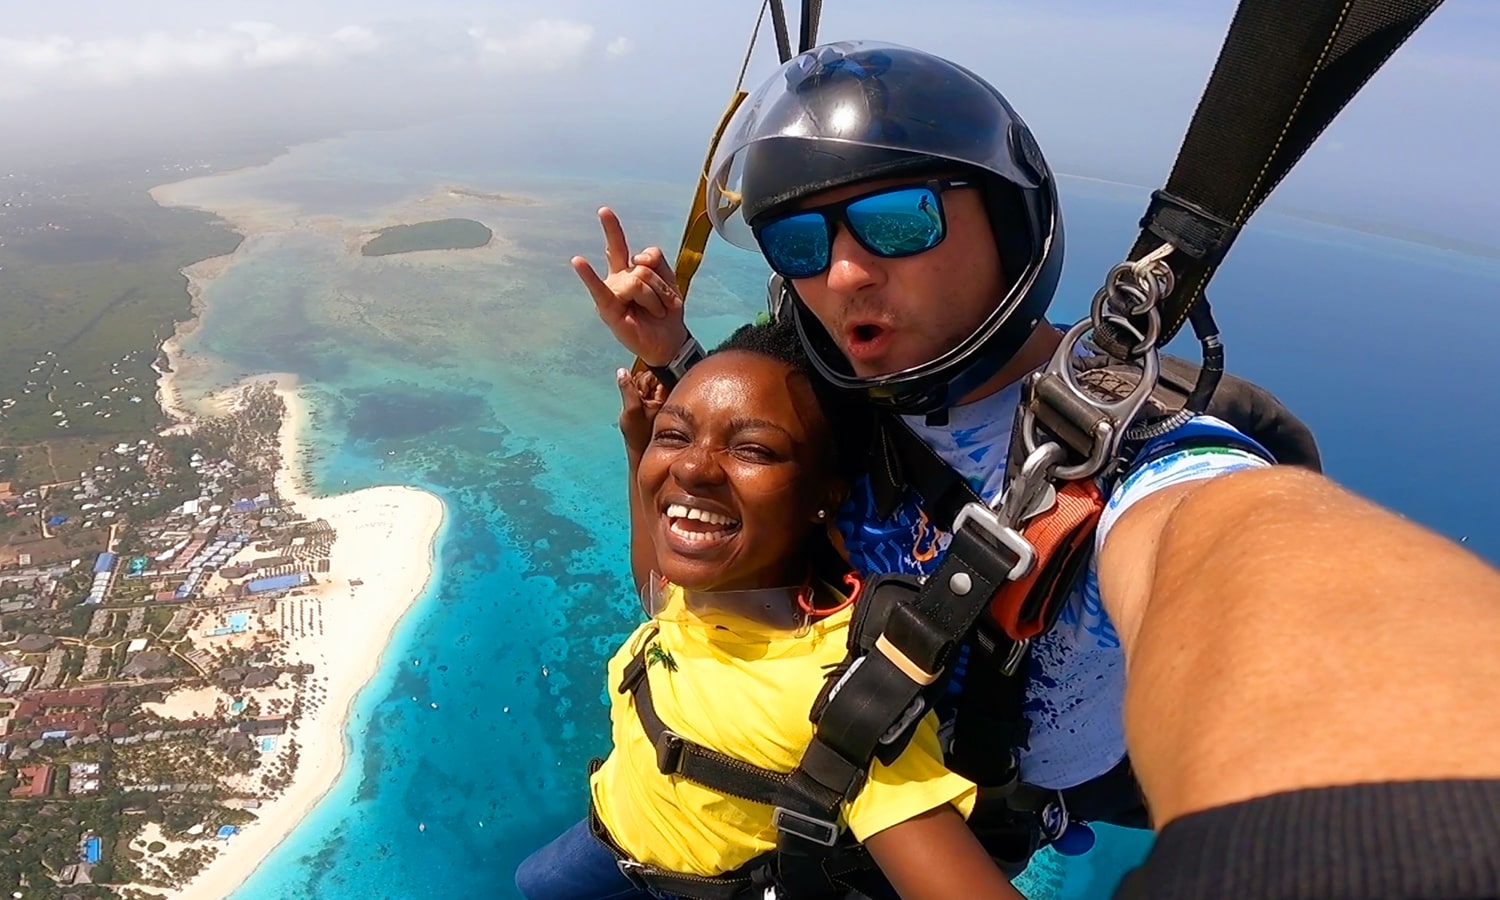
top-left (573, 42), bottom-right (1269, 867)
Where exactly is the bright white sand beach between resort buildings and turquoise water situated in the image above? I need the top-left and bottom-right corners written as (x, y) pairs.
top-left (167, 375), bottom-right (444, 900)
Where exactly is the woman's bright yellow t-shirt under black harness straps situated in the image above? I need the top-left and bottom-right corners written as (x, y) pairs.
top-left (590, 585), bottom-right (975, 876)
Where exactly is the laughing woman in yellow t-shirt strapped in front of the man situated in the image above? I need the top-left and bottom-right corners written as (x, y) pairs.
top-left (516, 318), bottom-right (1020, 900)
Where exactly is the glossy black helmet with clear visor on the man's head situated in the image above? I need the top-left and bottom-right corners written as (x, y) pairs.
top-left (708, 41), bottom-right (1064, 414)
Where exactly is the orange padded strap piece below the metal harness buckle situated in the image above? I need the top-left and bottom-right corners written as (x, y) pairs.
top-left (990, 479), bottom-right (1104, 641)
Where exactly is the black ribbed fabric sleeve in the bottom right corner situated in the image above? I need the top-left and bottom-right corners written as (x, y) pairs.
top-left (1115, 780), bottom-right (1500, 900)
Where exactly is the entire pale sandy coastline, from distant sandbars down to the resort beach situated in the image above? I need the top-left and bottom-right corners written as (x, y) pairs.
top-left (129, 167), bottom-right (504, 900)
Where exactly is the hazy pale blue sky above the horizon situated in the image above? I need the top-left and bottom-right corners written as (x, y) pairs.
top-left (0, 0), bottom-right (1500, 248)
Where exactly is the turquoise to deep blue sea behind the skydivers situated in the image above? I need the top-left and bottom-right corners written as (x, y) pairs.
top-left (155, 116), bottom-right (1500, 900)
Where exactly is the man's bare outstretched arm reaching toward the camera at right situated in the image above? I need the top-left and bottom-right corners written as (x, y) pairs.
top-left (1100, 467), bottom-right (1500, 827)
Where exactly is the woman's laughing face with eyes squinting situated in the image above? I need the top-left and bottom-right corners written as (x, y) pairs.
top-left (636, 351), bottom-right (834, 591)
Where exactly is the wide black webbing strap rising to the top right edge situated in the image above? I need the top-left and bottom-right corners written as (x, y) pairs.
top-left (1134, 0), bottom-right (1442, 351)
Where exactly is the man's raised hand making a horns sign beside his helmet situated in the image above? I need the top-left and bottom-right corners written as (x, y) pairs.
top-left (573, 207), bottom-right (687, 366)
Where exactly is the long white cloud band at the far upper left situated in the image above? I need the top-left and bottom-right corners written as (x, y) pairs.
top-left (0, 21), bottom-right (381, 96)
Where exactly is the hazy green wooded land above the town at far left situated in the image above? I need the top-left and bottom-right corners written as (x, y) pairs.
top-left (0, 164), bottom-right (240, 450)
